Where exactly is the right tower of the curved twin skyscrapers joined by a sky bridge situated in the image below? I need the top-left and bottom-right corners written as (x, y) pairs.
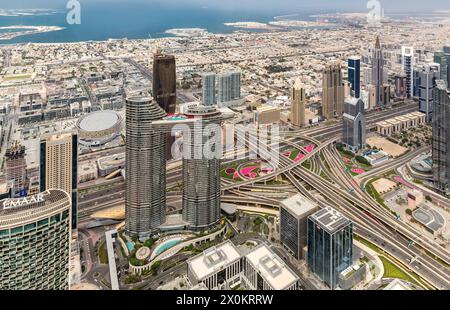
top-left (183, 106), bottom-right (222, 230)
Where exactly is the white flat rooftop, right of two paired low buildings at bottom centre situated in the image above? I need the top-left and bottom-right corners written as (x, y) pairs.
top-left (246, 244), bottom-right (298, 290)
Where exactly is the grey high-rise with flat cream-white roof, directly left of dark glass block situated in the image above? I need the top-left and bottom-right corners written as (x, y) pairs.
top-left (280, 195), bottom-right (319, 259)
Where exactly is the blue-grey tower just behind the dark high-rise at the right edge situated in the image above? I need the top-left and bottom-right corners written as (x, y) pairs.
top-left (419, 63), bottom-right (440, 122)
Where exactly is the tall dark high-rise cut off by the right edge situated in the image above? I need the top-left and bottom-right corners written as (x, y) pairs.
top-left (432, 80), bottom-right (450, 193)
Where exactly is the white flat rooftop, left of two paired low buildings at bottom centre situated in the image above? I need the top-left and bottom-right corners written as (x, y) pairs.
top-left (187, 240), bottom-right (241, 280)
